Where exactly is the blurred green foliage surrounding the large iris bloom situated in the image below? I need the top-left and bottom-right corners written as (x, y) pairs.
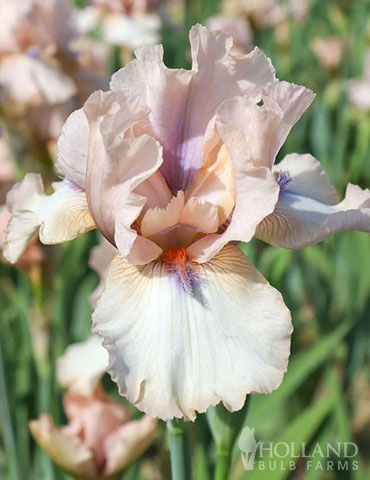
top-left (0, 0), bottom-right (370, 480)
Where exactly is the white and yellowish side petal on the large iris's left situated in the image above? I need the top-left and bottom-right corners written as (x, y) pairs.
top-left (4, 173), bottom-right (95, 263)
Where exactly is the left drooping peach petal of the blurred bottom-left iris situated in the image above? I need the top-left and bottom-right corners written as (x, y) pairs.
top-left (30, 415), bottom-right (99, 479)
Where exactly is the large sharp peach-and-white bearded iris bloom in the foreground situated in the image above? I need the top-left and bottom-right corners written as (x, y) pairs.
top-left (5, 26), bottom-right (370, 420)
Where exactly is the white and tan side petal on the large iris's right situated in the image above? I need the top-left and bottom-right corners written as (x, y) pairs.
top-left (256, 155), bottom-right (370, 248)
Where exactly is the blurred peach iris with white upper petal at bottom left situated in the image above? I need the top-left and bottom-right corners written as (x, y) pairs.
top-left (30, 336), bottom-right (156, 480)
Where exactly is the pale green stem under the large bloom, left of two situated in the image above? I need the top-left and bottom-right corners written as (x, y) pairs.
top-left (167, 419), bottom-right (192, 480)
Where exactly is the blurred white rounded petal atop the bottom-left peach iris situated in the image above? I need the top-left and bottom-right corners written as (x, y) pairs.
top-left (57, 335), bottom-right (108, 396)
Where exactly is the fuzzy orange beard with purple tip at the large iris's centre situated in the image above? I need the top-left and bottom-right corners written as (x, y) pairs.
top-left (162, 247), bottom-right (199, 294)
